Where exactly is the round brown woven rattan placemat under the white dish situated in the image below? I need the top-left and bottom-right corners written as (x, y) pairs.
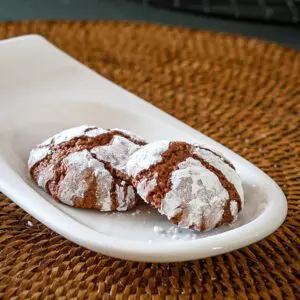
top-left (0, 22), bottom-right (300, 299)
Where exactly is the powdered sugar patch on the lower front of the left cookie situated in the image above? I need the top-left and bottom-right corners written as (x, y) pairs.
top-left (59, 150), bottom-right (113, 211)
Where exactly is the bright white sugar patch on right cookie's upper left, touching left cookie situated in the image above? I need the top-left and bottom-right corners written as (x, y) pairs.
top-left (126, 141), bottom-right (170, 177)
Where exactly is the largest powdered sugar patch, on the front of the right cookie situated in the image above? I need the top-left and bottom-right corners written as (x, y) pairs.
top-left (159, 158), bottom-right (228, 229)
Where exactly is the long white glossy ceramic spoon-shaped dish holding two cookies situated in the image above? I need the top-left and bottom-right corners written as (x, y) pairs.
top-left (0, 35), bottom-right (287, 262)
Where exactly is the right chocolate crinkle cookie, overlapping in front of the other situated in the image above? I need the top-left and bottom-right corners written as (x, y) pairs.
top-left (126, 141), bottom-right (244, 231)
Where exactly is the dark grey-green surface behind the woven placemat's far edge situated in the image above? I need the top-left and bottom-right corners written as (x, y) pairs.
top-left (0, 0), bottom-right (300, 49)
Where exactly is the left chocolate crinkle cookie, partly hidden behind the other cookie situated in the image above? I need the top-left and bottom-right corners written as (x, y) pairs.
top-left (28, 125), bottom-right (145, 211)
